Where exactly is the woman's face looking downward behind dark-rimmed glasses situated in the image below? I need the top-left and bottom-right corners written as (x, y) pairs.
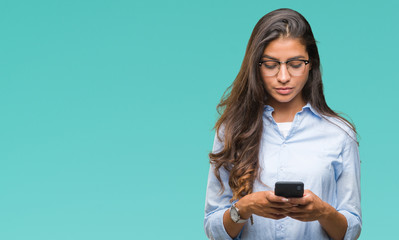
top-left (260, 38), bottom-right (310, 105)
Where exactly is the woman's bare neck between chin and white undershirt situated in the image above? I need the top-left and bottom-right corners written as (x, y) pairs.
top-left (268, 98), bottom-right (306, 122)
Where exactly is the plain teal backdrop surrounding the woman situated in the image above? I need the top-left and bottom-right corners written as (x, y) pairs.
top-left (0, 0), bottom-right (399, 240)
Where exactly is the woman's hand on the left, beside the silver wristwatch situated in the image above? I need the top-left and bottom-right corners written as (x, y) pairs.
top-left (236, 191), bottom-right (292, 219)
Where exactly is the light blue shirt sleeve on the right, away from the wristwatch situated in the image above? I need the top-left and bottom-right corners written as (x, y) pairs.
top-left (337, 134), bottom-right (362, 240)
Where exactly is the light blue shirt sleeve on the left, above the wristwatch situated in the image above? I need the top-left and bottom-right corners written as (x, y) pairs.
top-left (204, 134), bottom-right (239, 240)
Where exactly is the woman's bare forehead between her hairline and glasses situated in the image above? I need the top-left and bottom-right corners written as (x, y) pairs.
top-left (263, 38), bottom-right (308, 61)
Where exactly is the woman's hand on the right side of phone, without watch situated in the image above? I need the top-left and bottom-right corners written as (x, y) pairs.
top-left (286, 190), bottom-right (329, 222)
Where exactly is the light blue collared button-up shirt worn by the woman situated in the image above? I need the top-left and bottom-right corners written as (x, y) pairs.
top-left (204, 104), bottom-right (362, 240)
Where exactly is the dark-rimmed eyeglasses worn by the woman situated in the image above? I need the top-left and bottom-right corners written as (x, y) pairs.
top-left (259, 60), bottom-right (309, 77)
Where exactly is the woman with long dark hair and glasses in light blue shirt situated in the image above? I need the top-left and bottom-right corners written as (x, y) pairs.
top-left (204, 9), bottom-right (361, 240)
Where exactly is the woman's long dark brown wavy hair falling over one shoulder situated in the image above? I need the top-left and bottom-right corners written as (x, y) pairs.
top-left (209, 8), bottom-right (356, 201)
